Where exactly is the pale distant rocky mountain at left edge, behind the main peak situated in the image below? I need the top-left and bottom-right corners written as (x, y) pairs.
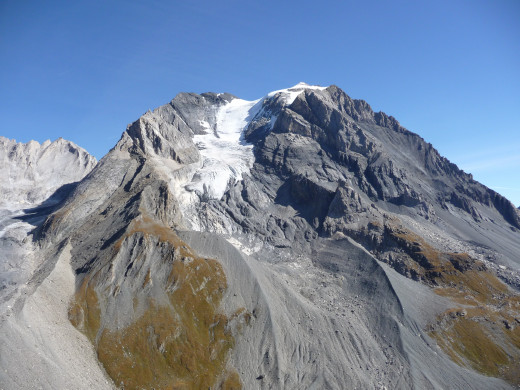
top-left (0, 137), bottom-right (96, 330)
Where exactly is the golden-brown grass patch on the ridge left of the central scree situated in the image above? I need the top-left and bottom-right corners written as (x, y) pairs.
top-left (69, 213), bottom-right (250, 389)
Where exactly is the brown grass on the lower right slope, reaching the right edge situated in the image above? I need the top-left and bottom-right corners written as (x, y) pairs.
top-left (385, 224), bottom-right (520, 384)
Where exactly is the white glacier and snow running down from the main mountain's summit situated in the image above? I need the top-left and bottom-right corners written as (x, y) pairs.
top-left (177, 83), bottom-right (326, 229)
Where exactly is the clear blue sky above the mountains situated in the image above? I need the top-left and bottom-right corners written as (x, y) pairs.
top-left (0, 0), bottom-right (520, 206)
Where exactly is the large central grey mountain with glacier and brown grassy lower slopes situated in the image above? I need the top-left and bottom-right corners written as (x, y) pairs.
top-left (0, 83), bottom-right (520, 389)
